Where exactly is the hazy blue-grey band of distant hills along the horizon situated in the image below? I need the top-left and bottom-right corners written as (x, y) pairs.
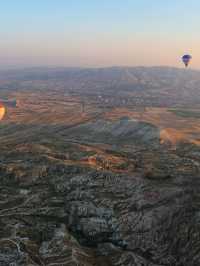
top-left (0, 67), bottom-right (200, 107)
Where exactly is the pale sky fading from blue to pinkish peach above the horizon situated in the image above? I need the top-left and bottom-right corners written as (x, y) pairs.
top-left (0, 0), bottom-right (200, 68)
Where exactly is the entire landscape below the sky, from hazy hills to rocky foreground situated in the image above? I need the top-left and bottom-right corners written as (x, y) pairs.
top-left (0, 67), bottom-right (200, 266)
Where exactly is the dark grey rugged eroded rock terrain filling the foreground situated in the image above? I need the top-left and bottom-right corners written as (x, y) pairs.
top-left (0, 145), bottom-right (200, 266)
